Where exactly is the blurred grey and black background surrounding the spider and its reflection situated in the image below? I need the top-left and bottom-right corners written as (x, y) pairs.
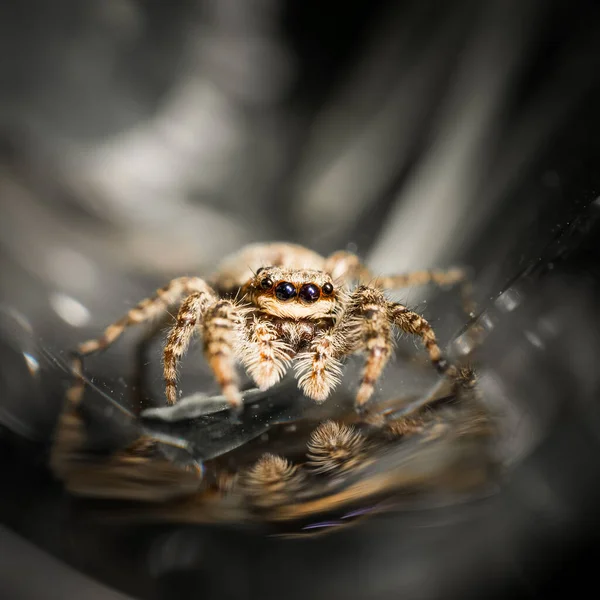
top-left (0, 0), bottom-right (600, 598)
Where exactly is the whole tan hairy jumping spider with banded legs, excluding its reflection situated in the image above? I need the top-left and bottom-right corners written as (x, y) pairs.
top-left (78, 243), bottom-right (464, 407)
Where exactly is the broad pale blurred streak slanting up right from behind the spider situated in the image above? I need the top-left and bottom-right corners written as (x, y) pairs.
top-left (370, 1), bottom-right (537, 271)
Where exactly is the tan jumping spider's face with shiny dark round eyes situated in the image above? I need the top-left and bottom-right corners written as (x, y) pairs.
top-left (246, 267), bottom-right (337, 319)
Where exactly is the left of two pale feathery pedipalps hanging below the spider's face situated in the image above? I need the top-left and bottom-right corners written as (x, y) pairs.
top-left (242, 317), bottom-right (291, 390)
